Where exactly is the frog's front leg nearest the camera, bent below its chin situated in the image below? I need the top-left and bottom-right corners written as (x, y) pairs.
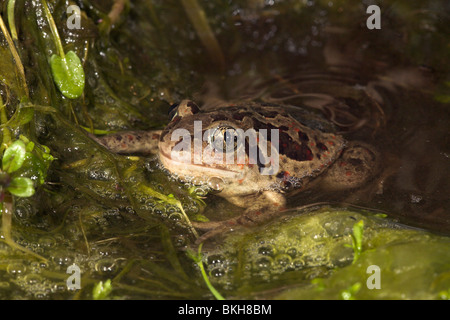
top-left (192, 191), bottom-right (286, 243)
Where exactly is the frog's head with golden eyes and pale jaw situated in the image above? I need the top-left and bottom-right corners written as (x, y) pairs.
top-left (159, 100), bottom-right (278, 193)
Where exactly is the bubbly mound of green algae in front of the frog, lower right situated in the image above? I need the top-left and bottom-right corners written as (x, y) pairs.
top-left (205, 208), bottom-right (450, 299)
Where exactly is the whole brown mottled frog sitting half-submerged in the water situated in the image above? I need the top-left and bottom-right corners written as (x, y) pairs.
top-left (94, 100), bottom-right (379, 241)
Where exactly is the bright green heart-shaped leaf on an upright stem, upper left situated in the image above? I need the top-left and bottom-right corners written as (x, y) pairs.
top-left (50, 51), bottom-right (85, 99)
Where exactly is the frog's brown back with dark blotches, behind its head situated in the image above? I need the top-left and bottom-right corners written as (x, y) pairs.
top-left (199, 102), bottom-right (345, 187)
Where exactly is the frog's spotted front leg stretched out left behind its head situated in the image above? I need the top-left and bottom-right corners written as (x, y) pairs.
top-left (90, 130), bottom-right (161, 154)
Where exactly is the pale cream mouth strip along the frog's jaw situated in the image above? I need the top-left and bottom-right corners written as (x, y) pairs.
top-left (159, 150), bottom-right (242, 179)
